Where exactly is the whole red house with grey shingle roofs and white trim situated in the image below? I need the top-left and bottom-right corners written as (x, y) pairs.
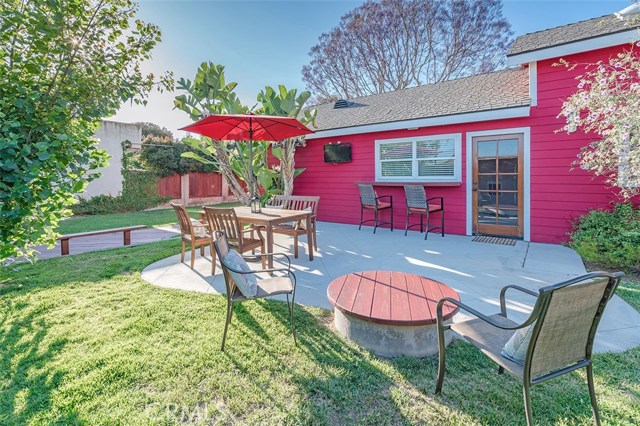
top-left (295, 15), bottom-right (637, 243)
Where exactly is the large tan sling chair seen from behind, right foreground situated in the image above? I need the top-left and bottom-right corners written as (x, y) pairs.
top-left (436, 272), bottom-right (624, 426)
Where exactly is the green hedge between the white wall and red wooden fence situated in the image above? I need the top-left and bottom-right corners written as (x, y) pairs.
top-left (72, 170), bottom-right (171, 215)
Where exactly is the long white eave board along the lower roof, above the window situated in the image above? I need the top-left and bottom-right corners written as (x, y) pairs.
top-left (306, 104), bottom-right (530, 139)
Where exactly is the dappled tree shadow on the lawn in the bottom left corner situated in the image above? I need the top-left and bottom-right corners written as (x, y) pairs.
top-left (0, 301), bottom-right (81, 425)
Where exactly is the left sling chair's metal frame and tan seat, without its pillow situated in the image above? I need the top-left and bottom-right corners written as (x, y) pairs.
top-left (213, 231), bottom-right (297, 351)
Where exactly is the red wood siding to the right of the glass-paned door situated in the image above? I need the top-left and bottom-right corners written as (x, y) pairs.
top-left (530, 46), bottom-right (624, 243)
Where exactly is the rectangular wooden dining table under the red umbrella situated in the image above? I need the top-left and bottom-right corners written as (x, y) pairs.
top-left (200, 207), bottom-right (313, 269)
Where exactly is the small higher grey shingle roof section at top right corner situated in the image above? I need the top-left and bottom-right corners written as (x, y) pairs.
top-left (507, 15), bottom-right (637, 56)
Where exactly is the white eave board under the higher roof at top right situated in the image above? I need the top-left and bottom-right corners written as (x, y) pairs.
top-left (507, 29), bottom-right (638, 66)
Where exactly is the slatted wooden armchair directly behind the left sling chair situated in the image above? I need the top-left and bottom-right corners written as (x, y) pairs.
top-left (204, 207), bottom-right (266, 275)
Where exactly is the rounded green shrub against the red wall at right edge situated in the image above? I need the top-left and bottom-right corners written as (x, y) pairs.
top-left (569, 203), bottom-right (640, 269)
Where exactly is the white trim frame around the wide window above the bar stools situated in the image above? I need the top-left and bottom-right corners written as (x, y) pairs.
top-left (375, 133), bottom-right (462, 183)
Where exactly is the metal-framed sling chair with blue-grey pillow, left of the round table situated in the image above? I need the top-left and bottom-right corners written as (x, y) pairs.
top-left (213, 231), bottom-right (297, 351)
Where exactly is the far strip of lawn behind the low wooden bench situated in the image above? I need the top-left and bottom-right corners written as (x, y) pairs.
top-left (58, 203), bottom-right (238, 234)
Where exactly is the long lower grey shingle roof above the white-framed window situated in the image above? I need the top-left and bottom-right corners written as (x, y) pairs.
top-left (316, 68), bottom-right (530, 130)
